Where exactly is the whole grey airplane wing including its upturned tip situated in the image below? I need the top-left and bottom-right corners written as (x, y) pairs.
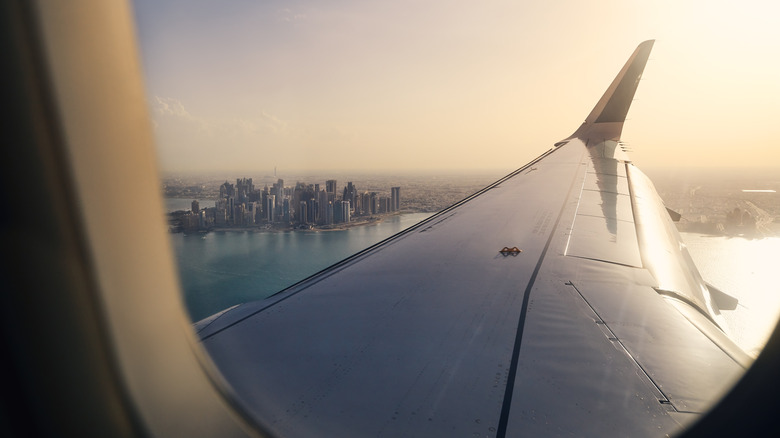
top-left (196, 41), bottom-right (749, 437)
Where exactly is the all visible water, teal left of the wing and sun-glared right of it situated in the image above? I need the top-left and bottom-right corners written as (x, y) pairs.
top-left (166, 199), bottom-right (780, 354)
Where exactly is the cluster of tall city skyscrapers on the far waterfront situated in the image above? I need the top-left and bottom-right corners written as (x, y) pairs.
top-left (181, 178), bottom-right (401, 231)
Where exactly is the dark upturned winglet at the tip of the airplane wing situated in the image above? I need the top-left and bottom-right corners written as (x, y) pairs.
top-left (569, 40), bottom-right (655, 141)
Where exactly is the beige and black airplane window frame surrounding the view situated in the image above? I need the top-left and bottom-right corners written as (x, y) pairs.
top-left (2, 1), bottom-right (780, 437)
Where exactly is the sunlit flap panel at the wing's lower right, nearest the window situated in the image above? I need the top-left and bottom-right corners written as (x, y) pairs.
top-left (575, 278), bottom-right (744, 413)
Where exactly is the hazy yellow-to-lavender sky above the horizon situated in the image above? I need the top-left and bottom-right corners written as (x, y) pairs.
top-left (134, 0), bottom-right (780, 172)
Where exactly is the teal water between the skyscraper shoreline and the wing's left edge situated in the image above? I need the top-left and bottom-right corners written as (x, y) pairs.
top-left (171, 213), bottom-right (430, 321)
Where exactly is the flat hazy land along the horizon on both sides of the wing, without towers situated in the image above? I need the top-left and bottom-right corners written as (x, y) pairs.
top-left (163, 169), bottom-right (780, 238)
